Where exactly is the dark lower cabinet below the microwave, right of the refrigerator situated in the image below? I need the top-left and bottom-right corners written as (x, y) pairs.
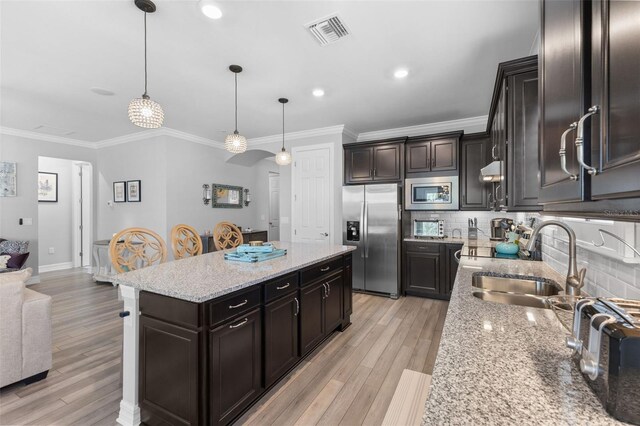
top-left (403, 241), bottom-right (462, 299)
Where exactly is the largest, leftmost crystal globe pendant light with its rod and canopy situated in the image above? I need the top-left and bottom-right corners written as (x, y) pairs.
top-left (129, 0), bottom-right (164, 129)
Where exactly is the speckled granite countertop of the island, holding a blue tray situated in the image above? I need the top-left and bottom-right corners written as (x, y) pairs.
top-left (114, 241), bottom-right (355, 303)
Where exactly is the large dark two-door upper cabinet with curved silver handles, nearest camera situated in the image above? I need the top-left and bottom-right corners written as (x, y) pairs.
top-left (540, 0), bottom-right (640, 216)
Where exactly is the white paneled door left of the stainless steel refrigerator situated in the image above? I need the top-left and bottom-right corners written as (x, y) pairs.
top-left (291, 144), bottom-right (333, 244)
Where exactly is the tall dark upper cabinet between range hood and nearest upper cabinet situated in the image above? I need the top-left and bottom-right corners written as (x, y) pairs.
top-left (489, 56), bottom-right (542, 211)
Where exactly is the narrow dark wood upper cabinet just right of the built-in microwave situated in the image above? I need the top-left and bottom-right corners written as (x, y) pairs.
top-left (460, 132), bottom-right (492, 210)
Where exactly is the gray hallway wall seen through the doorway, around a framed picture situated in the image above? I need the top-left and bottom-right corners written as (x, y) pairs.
top-left (38, 157), bottom-right (74, 266)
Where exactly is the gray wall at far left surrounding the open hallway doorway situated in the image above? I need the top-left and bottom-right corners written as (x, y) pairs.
top-left (0, 134), bottom-right (97, 276)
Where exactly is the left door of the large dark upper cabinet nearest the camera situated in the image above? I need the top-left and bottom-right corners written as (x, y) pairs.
top-left (539, 0), bottom-right (589, 203)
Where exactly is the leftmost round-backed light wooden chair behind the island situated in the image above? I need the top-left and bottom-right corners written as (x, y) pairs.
top-left (109, 228), bottom-right (167, 273)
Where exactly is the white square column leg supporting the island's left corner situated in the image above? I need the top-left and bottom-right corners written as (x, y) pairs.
top-left (116, 286), bottom-right (140, 426)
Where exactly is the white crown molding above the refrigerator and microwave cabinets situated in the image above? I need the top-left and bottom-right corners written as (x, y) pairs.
top-left (357, 115), bottom-right (488, 142)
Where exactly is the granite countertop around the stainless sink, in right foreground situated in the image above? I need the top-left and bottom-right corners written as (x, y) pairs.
top-left (422, 253), bottom-right (622, 425)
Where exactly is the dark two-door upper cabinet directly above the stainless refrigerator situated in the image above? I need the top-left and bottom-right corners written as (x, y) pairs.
top-left (344, 138), bottom-right (407, 185)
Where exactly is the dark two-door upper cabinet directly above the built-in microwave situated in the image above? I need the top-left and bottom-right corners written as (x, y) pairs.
top-left (405, 132), bottom-right (462, 177)
